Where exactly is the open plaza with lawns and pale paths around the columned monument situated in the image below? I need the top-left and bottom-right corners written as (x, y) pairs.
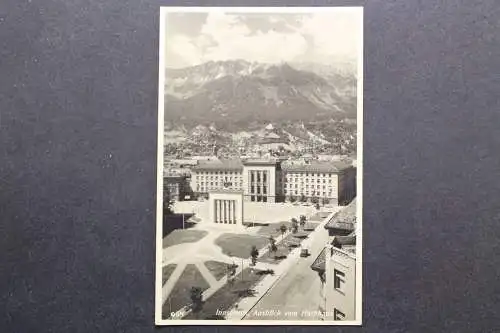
top-left (162, 196), bottom-right (335, 319)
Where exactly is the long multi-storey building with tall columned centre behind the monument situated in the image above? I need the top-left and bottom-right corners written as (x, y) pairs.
top-left (191, 158), bottom-right (356, 205)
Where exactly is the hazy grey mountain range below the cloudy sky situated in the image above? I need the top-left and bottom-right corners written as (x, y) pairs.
top-left (165, 60), bottom-right (357, 130)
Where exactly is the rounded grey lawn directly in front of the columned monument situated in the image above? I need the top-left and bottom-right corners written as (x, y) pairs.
top-left (215, 234), bottom-right (269, 259)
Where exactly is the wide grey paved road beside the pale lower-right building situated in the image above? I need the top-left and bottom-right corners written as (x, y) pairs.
top-left (244, 220), bottom-right (328, 320)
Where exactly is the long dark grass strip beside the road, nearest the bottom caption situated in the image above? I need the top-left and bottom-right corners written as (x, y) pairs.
top-left (183, 268), bottom-right (266, 319)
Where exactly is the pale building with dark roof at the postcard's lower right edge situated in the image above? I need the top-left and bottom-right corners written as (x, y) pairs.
top-left (311, 199), bottom-right (357, 321)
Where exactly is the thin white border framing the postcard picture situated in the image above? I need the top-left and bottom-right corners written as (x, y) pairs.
top-left (155, 6), bottom-right (364, 326)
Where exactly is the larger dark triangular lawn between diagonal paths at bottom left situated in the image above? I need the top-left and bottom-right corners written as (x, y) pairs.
top-left (162, 264), bottom-right (210, 318)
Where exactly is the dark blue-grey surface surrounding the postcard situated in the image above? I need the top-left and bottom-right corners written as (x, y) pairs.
top-left (0, 0), bottom-right (500, 332)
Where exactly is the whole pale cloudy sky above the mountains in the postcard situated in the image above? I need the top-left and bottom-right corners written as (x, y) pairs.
top-left (165, 9), bottom-right (362, 68)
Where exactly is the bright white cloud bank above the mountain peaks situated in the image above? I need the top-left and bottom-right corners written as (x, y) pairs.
top-left (167, 12), bottom-right (361, 65)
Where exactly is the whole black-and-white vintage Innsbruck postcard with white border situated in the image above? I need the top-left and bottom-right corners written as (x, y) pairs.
top-left (155, 7), bottom-right (363, 325)
